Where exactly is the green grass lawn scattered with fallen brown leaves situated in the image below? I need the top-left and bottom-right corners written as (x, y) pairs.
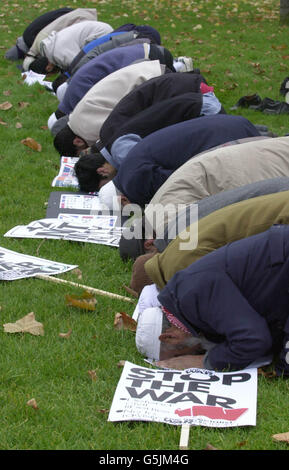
top-left (0, 0), bottom-right (289, 450)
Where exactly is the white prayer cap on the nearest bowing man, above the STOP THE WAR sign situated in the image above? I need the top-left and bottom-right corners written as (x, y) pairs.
top-left (135, 307), bottom-right (163, 361)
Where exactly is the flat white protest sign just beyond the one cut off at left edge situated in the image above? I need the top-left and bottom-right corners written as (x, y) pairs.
top-left (4, 215), bottom-right (122, 246)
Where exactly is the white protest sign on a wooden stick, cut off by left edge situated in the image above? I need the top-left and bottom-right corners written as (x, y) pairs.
top-left (0, 247), bottom-right (77, 281)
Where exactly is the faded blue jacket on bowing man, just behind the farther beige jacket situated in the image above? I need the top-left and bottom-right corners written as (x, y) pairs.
top-left (58, 44), bottom-right (150, 114)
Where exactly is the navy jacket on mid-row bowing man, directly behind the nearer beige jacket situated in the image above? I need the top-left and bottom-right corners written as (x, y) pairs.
top-left (113, 114), bottom-right (259, 207)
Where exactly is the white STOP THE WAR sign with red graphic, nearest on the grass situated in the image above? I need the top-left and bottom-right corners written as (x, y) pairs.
top-left (108, 362), bottom-right (257, 428)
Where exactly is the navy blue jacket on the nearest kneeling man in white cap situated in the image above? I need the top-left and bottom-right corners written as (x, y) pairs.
top-left (158, 225), bottom-right (289, 376)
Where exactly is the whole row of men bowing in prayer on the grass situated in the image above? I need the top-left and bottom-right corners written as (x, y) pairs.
top-left (6, 8), bottom-right (289, 376)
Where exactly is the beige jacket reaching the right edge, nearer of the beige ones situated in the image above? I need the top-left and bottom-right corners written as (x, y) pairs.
top-left (145, 137), bottom-right (289, 235)
